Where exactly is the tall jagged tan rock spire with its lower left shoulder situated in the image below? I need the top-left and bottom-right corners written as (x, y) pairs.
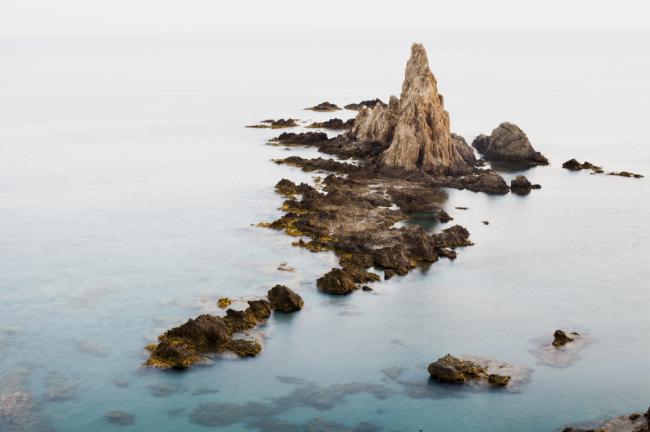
top-left (352, 43), bottom-right (473, 174)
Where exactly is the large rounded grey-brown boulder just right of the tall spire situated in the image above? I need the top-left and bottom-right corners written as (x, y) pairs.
top-left (472, 122), bottom-right (548, 165)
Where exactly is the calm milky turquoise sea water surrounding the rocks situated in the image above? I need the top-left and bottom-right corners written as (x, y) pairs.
top-left (0, 32), bottom-right (650, 432)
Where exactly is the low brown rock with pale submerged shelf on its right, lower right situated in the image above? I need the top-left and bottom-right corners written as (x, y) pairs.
top-left (427, 354), bottom-right (529, 390)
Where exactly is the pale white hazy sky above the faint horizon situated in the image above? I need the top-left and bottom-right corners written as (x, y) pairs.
top-left (0, 0), bottom-right (650, 37)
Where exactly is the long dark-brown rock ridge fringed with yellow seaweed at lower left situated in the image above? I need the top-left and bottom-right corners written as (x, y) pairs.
top-left (145, 285), bottom-right (303, 369)
